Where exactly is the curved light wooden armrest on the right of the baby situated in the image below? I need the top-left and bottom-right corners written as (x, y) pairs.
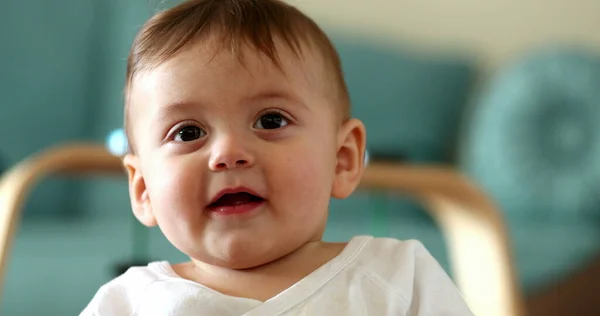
top-left (361, 163), bottom-right (524, 316)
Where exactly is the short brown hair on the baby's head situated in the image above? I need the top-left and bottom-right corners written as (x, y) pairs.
top-left (125, 0), bottom-right (350, 151)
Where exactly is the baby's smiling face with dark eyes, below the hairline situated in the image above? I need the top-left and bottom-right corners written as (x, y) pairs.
top-left (125, 40), bottom-right (352, 268)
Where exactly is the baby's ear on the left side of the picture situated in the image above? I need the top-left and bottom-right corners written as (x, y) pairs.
top-left (123, 154), bottom-right (157, 227)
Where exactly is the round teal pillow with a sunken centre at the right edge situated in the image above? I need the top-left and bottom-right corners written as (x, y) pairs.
top-left (460, 49), bottom-right (600, 220)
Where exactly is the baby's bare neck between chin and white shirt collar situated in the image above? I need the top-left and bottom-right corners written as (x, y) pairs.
top-left (173, 241), bottom-right (346, 302)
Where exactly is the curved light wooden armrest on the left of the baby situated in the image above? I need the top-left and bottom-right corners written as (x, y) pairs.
top-left (0, 144), bottom-right (124, 293)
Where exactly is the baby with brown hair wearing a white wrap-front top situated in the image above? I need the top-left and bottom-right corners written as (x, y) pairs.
top-left (81, 0), bottom-right (472, 316)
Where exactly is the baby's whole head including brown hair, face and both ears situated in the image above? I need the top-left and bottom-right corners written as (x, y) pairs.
top-left (124, 0), bottom-right (365, 269)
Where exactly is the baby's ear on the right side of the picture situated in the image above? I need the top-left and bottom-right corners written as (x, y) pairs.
top-left (331, 119), bottom-right (366, 199)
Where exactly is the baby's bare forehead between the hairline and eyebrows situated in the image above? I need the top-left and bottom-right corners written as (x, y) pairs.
top-left (129, 37), bottom-right (330, 104)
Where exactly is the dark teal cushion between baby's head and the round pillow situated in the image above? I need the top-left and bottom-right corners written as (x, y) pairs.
top-left (332, 35), bottom-right (474, 163)
